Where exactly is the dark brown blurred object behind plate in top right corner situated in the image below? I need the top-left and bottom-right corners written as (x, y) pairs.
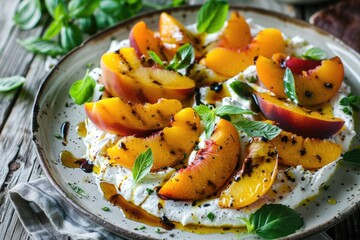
top-left (309, 1), bottom-right (360, 53)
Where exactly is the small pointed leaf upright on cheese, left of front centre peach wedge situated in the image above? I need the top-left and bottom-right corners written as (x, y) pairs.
top-left (132, 148), bottom-right (154, 185)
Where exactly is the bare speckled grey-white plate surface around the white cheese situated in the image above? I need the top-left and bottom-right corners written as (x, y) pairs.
top-left (33, 6), bottom-right (360, 240)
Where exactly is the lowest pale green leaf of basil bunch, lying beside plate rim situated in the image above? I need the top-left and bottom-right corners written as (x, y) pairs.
top-left (17, 37), bottom-right (66, 57)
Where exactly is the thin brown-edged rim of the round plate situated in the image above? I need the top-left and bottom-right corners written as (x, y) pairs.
top-left (31, 4), bottom-right (360, 240)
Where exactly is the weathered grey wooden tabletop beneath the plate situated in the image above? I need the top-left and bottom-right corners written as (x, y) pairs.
top-left (0, 0), bottom-right (360, 239)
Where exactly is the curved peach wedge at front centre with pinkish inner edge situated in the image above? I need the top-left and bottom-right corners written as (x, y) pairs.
top-left (158, 119), bottom-right (240, 200)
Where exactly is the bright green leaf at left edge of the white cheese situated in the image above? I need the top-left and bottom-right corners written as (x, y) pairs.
top-left (69, 71), bottom-right (96, 105)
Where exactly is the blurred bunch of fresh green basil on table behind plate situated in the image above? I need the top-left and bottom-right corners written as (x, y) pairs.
top-left (13, 0), bottom-right (186, 57)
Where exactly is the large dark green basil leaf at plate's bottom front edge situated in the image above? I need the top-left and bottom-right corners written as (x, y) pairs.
top-left (249, 204), bottom-right (304, 239)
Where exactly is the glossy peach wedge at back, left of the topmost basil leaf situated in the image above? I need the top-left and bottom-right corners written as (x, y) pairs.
top-left (159, 12), bottom-right (202, 59)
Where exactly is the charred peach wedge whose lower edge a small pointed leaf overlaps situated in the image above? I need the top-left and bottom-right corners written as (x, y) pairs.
top-left (107, 108), bottom-right (202, 171)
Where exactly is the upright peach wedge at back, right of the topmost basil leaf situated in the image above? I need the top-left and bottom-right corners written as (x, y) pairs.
top-left (219, 12), bottom-right (252, 49)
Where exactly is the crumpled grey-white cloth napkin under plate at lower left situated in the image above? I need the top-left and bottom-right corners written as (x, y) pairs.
top-left (9, 178), bottom-right (124, 240)
